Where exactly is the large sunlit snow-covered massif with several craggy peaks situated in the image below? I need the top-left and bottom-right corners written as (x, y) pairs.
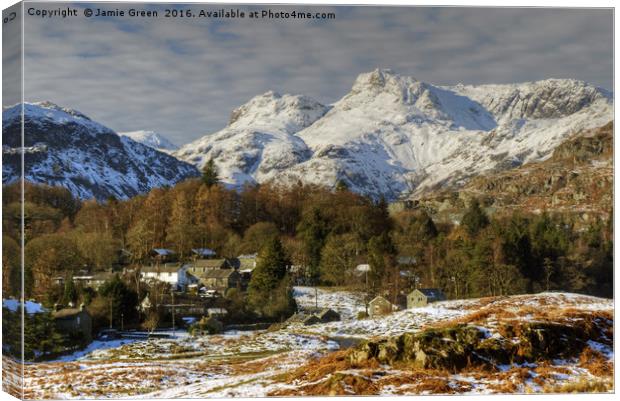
top-left (174, 69), bottom-right (613, 198)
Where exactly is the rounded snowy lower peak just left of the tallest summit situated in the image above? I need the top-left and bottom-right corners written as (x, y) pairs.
top-left (174, 92), bottom-right (327, 186)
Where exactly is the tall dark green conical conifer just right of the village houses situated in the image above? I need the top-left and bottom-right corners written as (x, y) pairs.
top-left (248, 237), bottom-right (292, 318)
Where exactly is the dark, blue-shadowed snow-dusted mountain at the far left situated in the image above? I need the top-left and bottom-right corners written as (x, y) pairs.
top-left (2, 102), bottom-right (199, 199)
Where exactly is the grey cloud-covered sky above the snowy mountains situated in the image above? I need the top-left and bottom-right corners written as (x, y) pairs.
top-left (19, 3), bottom-right (613, 145)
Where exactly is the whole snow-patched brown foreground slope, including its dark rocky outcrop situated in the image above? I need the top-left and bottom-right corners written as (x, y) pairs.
top-left (15, 288), bottom-right (614, 399)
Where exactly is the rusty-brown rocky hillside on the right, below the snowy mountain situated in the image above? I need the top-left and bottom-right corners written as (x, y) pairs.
top-left (419, 122), bottom-right (613, 221)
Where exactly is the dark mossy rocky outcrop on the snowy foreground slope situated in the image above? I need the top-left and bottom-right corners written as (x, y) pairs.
top-left (349, 322), bottom-right (602, 371)
